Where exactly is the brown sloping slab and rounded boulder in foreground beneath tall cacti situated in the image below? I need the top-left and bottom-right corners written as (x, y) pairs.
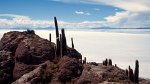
top-left (13, 56), bottom-right (83, 84)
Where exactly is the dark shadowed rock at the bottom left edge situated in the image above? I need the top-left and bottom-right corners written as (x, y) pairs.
top-left (0, 51), bottom-right (15, 84)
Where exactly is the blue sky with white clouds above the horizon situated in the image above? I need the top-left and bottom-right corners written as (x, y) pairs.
top-left (0, 0), bottom-right (150, 29)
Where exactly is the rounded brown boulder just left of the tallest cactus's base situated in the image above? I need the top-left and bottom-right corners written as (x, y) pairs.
top-left (15, 35), bottom-right (54, 64)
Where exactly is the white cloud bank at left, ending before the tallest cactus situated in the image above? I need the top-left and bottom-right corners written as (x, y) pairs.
top-left (0, 14), bottom-right (52, 28)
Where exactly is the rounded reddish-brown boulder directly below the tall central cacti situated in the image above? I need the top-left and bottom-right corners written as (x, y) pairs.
top-left (58, 56), bottom-right (83, 82)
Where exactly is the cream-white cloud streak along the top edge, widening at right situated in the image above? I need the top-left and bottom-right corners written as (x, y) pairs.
top-left (52, 0), bottom-right (150, 12)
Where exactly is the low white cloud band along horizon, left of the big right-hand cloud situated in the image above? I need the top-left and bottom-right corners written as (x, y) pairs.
top-left (0, 14), bottom-right (104, 29)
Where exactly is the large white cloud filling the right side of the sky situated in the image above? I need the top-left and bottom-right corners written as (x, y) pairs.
top-left (50, 0), bottom-right (150, 28)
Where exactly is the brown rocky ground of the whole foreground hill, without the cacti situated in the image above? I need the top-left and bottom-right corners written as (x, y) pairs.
top-left (0, 31), bottom-right (150, 84)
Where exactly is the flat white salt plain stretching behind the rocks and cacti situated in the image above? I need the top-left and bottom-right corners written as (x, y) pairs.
top-left (0, 30), bottom-right (150, 78)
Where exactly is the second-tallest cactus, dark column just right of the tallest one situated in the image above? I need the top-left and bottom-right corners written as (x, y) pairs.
top-left (61, 29), bottom-right (67, 56)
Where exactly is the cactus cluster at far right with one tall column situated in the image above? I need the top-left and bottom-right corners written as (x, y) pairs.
top-left (126, 60), bottom-right (139, 84)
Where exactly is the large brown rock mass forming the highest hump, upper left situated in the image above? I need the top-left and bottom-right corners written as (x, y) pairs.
top-left (0, 30), bottom-right (55, 64)
